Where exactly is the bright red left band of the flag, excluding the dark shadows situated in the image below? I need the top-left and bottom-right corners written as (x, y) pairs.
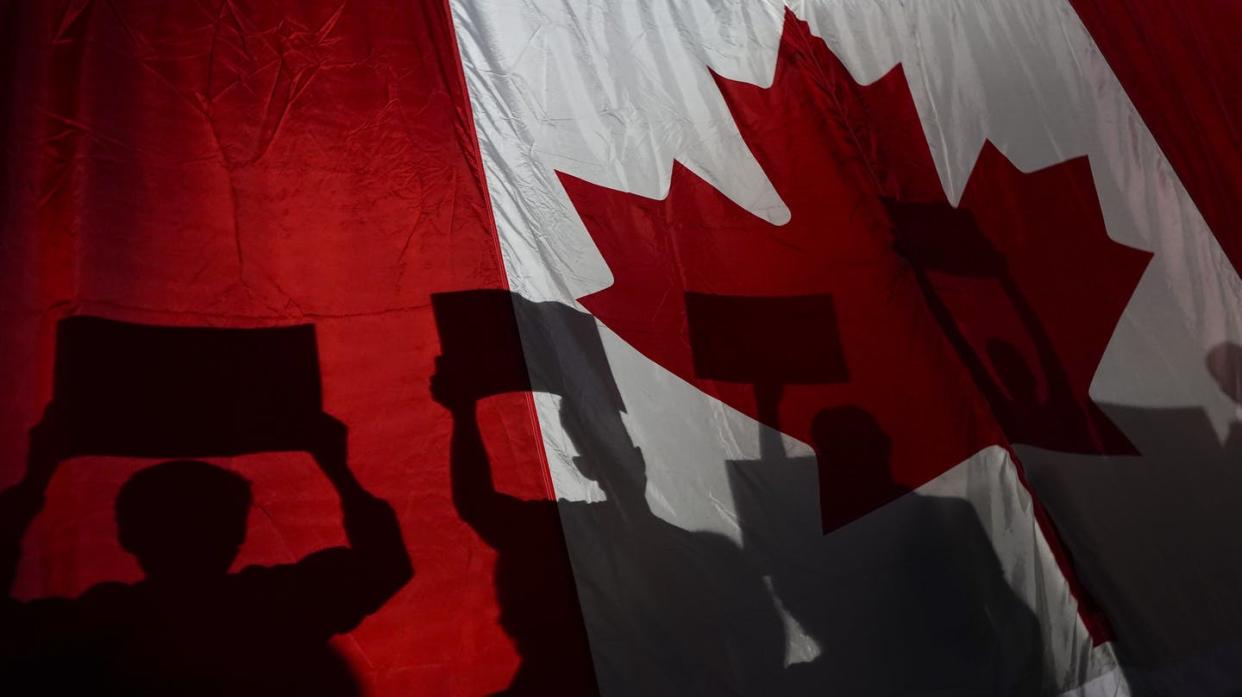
top-left (0, 0), bottom-right (563, 695)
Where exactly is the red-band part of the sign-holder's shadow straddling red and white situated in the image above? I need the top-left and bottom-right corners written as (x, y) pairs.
top-left (431, 289), bottom-right (597, 696)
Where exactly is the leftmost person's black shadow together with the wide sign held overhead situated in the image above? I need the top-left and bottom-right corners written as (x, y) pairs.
top-left (2, 317), bottom-right (414, 695)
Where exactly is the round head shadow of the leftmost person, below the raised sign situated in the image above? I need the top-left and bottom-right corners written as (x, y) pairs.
top-left (116, 460), bottom-right (251, 583)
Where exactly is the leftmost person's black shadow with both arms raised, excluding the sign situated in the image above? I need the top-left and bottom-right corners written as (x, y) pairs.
top-left (0, 416), bottom-right (414, 696)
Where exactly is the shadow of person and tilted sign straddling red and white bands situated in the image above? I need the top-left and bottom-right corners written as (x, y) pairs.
top-left (432, 291), bottom-right (784, 697)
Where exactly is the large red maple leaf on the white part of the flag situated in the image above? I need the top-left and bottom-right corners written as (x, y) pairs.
top-left (560, 14), bottom-right (1150, 531)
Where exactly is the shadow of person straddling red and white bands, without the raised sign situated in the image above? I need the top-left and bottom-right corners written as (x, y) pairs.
top-left (433, 360), bottom-right (785, 696)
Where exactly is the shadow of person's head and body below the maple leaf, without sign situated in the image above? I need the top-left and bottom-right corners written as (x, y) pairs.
top-left (775, 406), bottom-right (1051, 697)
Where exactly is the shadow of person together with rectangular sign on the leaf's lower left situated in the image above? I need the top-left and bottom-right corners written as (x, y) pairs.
top-left (686, 293), bottom-right (1052, 697)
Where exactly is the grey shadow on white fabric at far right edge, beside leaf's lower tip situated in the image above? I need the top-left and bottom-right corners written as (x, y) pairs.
top-left (1021, 343), bottom-right (1242, 696)
